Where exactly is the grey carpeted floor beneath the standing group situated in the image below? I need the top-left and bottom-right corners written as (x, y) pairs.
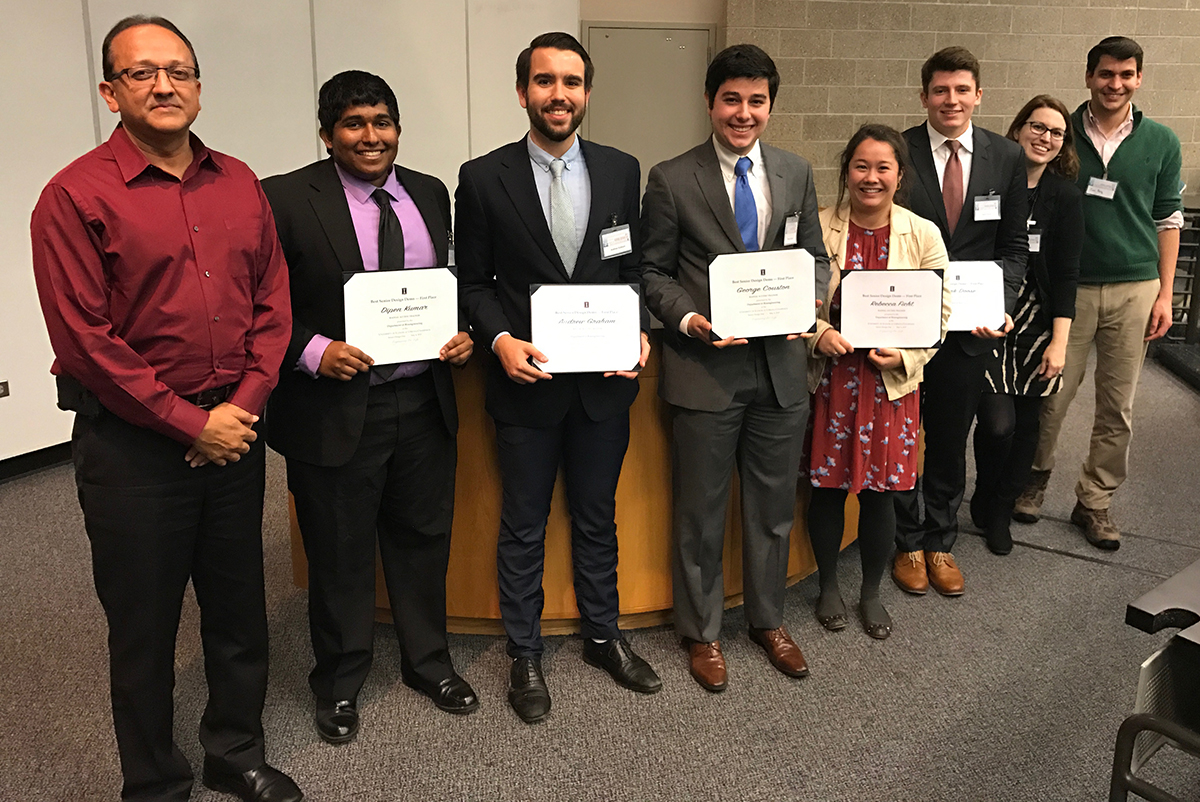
top-left (0, 363), bottom-right (1200, 802)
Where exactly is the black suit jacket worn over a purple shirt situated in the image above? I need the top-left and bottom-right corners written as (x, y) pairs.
top-left (263, 158), bottom-right (458, 466)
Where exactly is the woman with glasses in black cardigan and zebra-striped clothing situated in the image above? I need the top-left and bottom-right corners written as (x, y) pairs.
top-left (971, 95), bottom-right (1084, 555)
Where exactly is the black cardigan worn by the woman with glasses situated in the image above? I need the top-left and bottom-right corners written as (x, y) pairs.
top-left (1030, 173), bottom-right (1084, 327)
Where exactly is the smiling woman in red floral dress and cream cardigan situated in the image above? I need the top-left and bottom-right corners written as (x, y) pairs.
top-left (808, 125), bottom-right (949, 640)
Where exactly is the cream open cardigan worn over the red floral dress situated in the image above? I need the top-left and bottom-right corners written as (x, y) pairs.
top-left (809, 204), bottom-right (950, 401)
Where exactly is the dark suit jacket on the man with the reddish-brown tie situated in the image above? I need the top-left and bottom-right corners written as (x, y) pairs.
top-left (904, 122), bottom-right (1028, 354)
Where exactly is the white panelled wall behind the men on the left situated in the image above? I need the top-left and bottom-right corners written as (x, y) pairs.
top-left (0, 0), bottom-right (580, 460)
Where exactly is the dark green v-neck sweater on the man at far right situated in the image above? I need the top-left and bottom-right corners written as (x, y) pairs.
top-left (1070, 103), bottom-right (1183, 285)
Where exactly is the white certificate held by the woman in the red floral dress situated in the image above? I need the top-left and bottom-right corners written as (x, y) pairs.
top-left (840, 270), bottom-right (942, 348)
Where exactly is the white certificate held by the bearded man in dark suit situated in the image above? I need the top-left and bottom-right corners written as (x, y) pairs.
top-left (529, 285), bottom-right (642, 373)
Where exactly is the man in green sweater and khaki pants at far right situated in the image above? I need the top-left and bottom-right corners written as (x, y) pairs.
top-left (1013, 36), bottom-right (1183, 551)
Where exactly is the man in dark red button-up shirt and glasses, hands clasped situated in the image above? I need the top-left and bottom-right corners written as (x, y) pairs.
top-left (32, 17), bottom-right (302, 802)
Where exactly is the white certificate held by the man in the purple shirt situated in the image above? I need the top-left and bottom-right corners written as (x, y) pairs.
top-left (342, 268), bottom-right (458, 365)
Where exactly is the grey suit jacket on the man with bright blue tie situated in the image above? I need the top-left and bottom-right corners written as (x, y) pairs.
top-left (642, 139), bottom-right (829, 412)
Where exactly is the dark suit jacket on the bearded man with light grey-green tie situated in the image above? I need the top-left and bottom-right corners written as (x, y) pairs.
top-left (455, 139), bottom-right (649, 427)
